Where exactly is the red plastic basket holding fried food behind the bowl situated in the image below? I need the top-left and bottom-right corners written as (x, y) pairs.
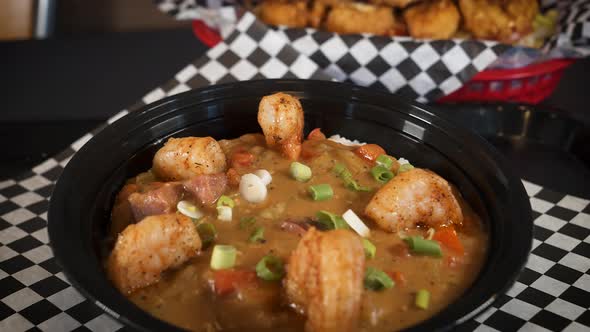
top-left (193, 20), bottom-right (574, 104)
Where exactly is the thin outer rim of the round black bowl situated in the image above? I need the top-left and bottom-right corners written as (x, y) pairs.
top-left (47, 79), bottom-right (533, 331)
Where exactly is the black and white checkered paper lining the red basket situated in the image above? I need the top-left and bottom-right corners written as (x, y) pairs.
top-left (155, 0), bottom-right (590, 102)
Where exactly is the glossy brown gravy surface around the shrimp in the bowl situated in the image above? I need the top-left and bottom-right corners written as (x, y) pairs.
top-left (108, 135), bottom-right (487, 331)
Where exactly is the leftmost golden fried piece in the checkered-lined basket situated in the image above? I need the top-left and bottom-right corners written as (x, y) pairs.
top-left (258, 1), bottom-right (308, 28)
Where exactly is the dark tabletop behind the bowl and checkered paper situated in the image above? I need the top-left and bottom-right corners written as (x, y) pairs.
top-left (0, 29), bottom-right (590, 198)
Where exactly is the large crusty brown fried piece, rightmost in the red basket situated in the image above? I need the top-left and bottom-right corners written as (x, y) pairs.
top-left (459, 0), bottom-right (539, 43)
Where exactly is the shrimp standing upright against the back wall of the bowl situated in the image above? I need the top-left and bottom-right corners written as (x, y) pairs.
top-left (258, 92), bottom-right (303, 160)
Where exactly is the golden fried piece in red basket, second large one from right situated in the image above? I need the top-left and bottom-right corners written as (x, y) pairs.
top-left (404, 0), bottom-right (461, 39)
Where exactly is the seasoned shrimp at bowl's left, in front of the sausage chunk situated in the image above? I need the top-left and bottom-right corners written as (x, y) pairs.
top-left (107, 213), bottom-right (201, 294)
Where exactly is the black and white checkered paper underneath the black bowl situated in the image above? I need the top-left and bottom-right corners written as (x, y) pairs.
top-left (0, 16), bottom-right (590, 332)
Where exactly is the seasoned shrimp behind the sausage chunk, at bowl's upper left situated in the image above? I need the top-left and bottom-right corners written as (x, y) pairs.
top-left (153, 137), bottom-right (227, 181)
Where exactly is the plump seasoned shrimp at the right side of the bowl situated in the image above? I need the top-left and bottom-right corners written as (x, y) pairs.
top-left (365, 168), bottom-right (463, 232)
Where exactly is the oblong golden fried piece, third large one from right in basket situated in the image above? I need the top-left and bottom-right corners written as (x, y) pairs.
top-left (325, 3), bottom-right (395, 35)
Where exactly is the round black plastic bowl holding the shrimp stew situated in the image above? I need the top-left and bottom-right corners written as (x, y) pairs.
top-left (49, 80), bottom-right (532, 331)
